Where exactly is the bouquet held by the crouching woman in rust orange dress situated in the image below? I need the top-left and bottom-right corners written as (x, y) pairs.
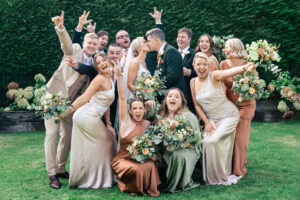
top-left (127, 132), bottom-right (156, 163)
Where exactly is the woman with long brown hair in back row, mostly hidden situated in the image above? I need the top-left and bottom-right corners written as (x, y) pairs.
top-left (195, 34), bottom-right (220, 71)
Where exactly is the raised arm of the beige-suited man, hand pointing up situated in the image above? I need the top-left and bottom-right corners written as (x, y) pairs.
top-left (51, 11), bottom-right (73, 56)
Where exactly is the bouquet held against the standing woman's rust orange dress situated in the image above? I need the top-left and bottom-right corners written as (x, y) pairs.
top-left (231, 69), bottom-right (270, 105)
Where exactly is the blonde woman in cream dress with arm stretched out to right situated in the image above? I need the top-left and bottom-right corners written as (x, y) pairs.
top-left (191, 52), bottom-right (253, 185)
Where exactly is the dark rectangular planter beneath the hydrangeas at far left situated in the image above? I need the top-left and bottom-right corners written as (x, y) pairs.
top-left (0, 111), bottom-right (45, 132)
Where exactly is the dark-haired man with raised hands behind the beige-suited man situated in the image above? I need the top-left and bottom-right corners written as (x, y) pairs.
top-left (72, 11), bottom-right (109, 54)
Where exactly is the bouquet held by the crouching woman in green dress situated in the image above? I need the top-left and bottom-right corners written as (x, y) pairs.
top-left (157, 116), bottom-right (195, 152)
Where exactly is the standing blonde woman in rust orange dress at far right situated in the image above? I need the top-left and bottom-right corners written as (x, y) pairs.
top-left (221, 38), bottom-right (257, 178)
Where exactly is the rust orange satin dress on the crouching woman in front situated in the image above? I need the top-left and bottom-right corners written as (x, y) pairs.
top-left (111, 121), bottom-right (161, 196)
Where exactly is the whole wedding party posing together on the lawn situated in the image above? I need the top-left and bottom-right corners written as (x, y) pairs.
top-left (44, 8), bottom-right (257, 196)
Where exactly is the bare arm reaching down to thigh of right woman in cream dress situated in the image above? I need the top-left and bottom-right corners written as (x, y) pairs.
top-left (190, 77), bottom-right (214, 133)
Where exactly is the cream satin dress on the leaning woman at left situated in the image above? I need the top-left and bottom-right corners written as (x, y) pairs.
top-left (69, 80), bottom-right (116, 188)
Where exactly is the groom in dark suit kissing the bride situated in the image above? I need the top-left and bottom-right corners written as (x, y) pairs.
top-left (146, 28), bottom-right (188, 99)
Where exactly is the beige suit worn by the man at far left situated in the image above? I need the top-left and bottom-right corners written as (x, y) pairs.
top-left (44, 27), bottom-right (83, 176)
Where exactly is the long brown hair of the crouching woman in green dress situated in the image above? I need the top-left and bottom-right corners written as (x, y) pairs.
top-left (159, 88), bottom-right (188, 119)
